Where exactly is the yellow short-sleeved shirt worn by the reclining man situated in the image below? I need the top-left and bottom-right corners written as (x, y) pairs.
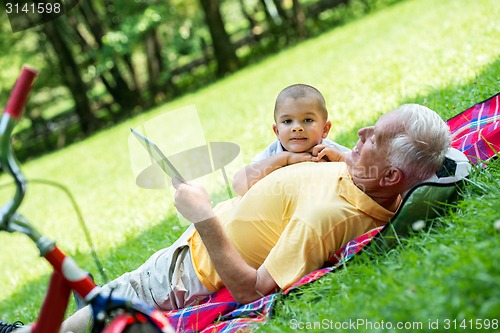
top-left (188, 162), bottom-right (398, 291)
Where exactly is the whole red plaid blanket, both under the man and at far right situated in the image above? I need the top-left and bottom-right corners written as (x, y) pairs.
top-left (161, 93), bottom-right (500, 333)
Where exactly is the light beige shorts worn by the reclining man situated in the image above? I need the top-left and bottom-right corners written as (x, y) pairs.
top-left (103, 226), bottom-right (211, 310)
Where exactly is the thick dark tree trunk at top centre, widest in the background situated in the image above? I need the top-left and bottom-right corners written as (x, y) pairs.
top-left (200, 0), bottom-right (240, 77)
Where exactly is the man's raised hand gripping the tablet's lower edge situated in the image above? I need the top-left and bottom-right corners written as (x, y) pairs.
top-left (172, 178), bottom-right (215, 223)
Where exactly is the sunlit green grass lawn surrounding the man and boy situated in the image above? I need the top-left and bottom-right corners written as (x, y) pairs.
top-left (0, 0), bottom-right (500, 332)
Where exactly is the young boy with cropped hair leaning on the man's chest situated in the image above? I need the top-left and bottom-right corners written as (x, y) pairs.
top-left (233, 84), bottom-right (350, 196)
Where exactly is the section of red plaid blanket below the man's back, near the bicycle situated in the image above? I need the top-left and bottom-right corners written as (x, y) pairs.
top-left (164, 227), bottom-right (382, 333)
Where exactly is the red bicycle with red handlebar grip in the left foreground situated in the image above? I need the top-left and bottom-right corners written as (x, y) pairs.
top-left (0, 66), bottom-right (174, 333)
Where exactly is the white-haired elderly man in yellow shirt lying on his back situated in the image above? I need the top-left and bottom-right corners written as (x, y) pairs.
top-left (63, 104), bottom-right (450, 332)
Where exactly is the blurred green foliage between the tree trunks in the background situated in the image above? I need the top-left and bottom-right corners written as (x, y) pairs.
top-left (0, 0), bottom-right (406, 160)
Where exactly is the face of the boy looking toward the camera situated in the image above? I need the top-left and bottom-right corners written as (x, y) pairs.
top-left (273, 97), bottom-right (331, 153)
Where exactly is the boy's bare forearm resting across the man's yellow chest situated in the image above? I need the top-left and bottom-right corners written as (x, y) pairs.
top-left (233, 151), bottom-right (313, 196)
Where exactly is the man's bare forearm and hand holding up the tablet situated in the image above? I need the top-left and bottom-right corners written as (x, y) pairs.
top-left (174, 182), bottom-right (278, 303)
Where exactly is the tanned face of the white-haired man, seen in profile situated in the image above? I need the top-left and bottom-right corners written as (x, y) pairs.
top-left (346, 112), bottom-right (402, 185)
